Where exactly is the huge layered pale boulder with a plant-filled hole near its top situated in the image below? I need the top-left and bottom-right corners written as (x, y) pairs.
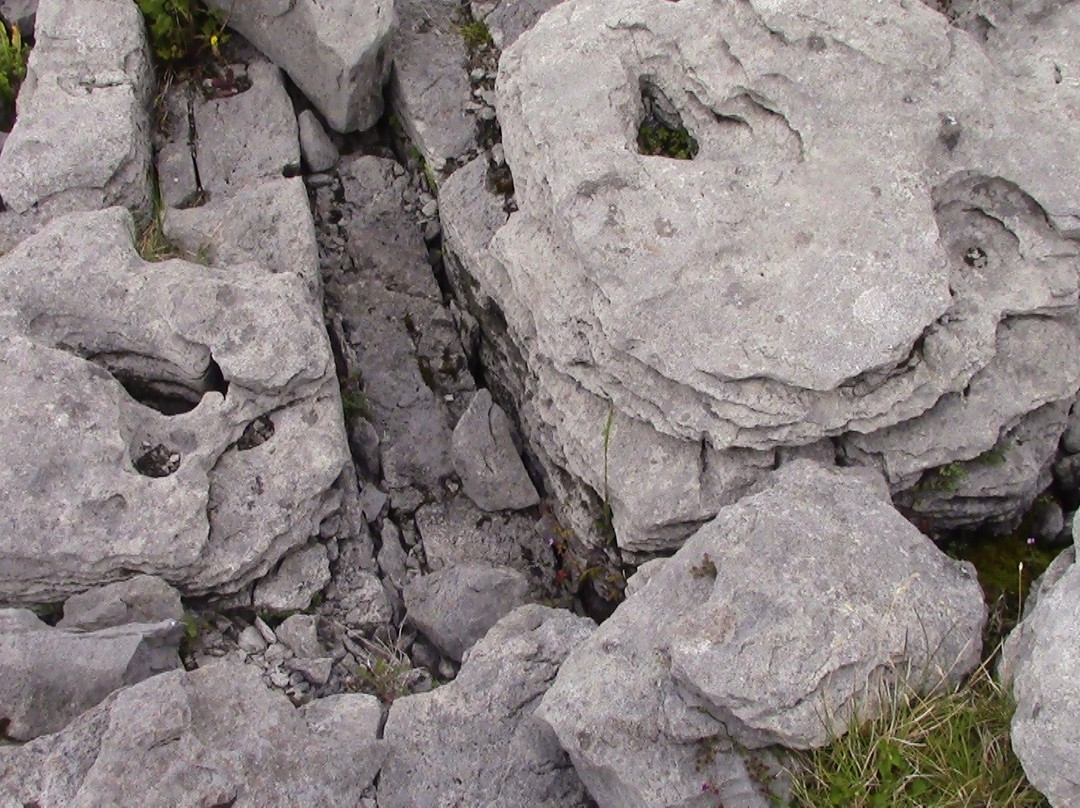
top-left (441, 0), bottom-right (1080, 549)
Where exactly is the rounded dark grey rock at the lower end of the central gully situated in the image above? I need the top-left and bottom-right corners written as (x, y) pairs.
top-left (405, 564), bottom-right (529, 662)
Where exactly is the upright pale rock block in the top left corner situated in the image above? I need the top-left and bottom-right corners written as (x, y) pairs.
top-left (0, 0), bottom-right (153, 217)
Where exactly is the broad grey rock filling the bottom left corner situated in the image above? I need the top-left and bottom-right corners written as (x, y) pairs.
top-left (0, 663), bottom-right (384, 808)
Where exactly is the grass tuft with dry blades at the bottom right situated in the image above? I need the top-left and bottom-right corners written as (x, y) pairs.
top-left (789, 662), bottom-right (1047, 808)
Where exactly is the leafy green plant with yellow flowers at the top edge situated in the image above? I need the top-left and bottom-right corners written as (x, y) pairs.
top-left (138, 0), bottom-right (227, 67)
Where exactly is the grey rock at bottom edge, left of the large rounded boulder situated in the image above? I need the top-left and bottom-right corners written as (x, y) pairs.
top-left (379, 605), bottom-right (594, 808)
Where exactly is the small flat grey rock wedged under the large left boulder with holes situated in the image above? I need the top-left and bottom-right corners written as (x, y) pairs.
top-left (57, 575), bottom-right (184, 631)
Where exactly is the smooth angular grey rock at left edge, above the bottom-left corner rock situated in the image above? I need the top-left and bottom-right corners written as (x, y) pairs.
top-left (0, 609), bottom-right (184, 743)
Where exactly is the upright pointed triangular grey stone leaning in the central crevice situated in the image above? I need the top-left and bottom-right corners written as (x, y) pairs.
top-left (451, 390), bottom-right (540, 511)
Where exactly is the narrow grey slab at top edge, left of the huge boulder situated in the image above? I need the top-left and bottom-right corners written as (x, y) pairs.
top-left (390, 0), bottom-right (476, 172)
